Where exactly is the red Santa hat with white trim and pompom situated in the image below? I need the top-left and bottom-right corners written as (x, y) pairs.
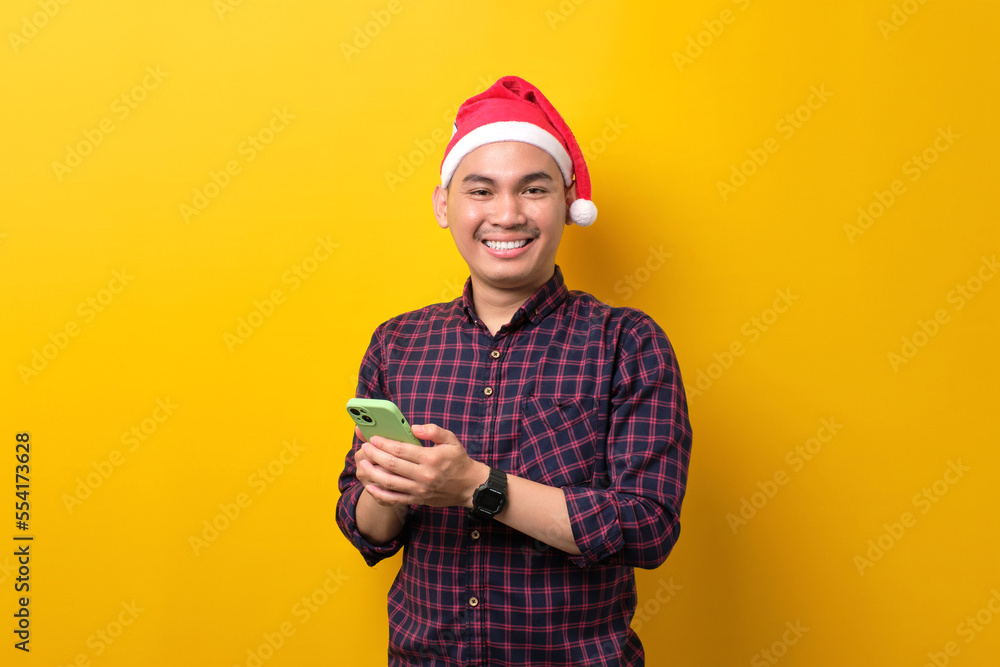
top-left (441, 76), bottom-right (597, 227)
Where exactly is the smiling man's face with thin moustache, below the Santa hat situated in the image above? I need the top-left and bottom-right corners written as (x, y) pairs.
top-left (433, 141), bottom-right (573, 294)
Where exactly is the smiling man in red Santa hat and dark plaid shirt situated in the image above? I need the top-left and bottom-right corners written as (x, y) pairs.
top-left (337, 77), bottom-right (691, 667)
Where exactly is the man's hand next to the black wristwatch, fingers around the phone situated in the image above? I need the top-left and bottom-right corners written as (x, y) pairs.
top-left (355, 424), bottom-right (490, 507)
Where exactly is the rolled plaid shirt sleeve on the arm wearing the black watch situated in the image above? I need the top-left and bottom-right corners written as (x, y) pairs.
top-left (563, 317), bottom-right (691, 569)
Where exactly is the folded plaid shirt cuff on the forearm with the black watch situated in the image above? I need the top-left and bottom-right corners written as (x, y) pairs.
top-left (563, 486), bottom-right (625, 567)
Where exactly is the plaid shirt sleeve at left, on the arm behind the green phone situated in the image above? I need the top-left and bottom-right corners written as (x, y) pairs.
top-left (337, 327), bottom-right (408, 566)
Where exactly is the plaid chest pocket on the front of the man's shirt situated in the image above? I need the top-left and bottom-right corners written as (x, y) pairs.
top-left (516, 396), bottom-right (597, 486)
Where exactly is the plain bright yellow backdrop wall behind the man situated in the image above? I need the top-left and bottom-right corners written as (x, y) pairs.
top-left (0, 0), bottom-right (1000, 667)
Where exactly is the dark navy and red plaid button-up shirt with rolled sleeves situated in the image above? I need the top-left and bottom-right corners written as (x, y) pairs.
top-left (337, 267), bottom-right (691, 667)
